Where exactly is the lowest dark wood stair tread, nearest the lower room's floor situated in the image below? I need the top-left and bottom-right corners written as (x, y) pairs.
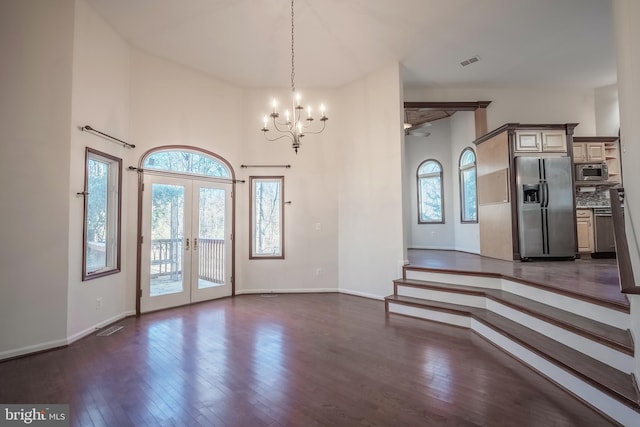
top-left (385, 295), bottom-right (640, 411)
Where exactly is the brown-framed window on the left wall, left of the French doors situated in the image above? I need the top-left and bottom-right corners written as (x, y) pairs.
top-left (82, 147), bottom-right (122, 280)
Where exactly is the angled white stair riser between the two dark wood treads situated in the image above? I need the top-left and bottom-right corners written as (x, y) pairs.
top-left (487, 299), bottom-right (634, 374)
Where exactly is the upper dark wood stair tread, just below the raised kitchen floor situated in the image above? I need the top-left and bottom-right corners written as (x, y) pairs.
top-left (394, 279), bottom-right (634, 356)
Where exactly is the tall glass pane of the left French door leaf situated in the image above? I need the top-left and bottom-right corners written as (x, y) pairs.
top-left (150, 183), bottom-right (185, 296)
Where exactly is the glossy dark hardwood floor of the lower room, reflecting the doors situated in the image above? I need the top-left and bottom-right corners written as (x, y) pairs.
top-left (0, 294), bottom-right (611, 427)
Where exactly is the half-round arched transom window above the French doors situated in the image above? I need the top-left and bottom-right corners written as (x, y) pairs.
top-left (143, 148), bottom-right (231, 179)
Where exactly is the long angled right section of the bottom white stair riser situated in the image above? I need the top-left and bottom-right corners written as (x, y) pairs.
top-left (471, 319), bottom-right (640, 426)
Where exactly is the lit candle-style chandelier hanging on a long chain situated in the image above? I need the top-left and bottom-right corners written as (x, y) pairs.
top-left (262, 0), bottom-right (329, 154)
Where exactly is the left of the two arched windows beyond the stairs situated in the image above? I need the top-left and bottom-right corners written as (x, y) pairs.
top-left (418, 159), bottom-right (444, 224)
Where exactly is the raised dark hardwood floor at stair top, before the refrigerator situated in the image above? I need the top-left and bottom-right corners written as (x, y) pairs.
top-left (408, 249), bottom-right (629, 311)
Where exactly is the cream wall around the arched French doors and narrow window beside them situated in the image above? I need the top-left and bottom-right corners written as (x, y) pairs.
top-left (129, 52), bottom-right (338, 301)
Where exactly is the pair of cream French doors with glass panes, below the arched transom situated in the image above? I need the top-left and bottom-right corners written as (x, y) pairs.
top-left (140, 175), bottom-right (231, 313)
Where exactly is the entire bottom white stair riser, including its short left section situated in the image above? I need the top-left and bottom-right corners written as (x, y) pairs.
top-left (382, 302), bottom-right (640, 426)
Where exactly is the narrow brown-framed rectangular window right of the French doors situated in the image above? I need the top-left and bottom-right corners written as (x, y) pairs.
top-left (249, 176), bottom-right (284, 258)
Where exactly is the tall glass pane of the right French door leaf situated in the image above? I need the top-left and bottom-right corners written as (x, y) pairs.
top-left (197, 187), bottom-right (226, 289)
